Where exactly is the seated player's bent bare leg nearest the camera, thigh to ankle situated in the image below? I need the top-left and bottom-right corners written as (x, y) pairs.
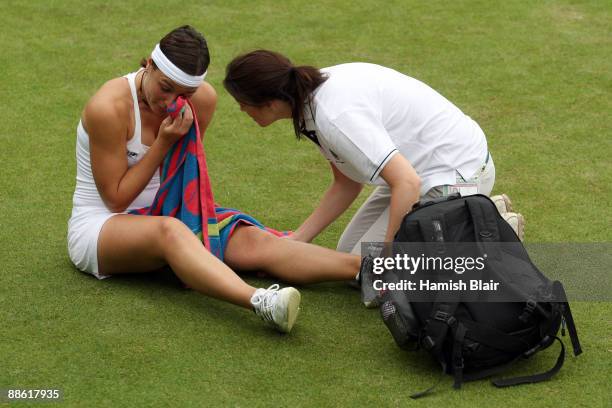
top-left (98, 214), bottom-right (255, 308)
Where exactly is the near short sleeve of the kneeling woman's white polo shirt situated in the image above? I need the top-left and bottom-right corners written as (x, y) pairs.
top-left (322, 109), bottom-right (398, 182)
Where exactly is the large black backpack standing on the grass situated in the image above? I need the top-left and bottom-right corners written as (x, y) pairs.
top-left (376, 194), bottom-right (582, 398)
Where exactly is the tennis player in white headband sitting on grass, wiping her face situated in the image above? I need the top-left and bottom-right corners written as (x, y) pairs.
top-left (68, 26), bottom-right (360, 332)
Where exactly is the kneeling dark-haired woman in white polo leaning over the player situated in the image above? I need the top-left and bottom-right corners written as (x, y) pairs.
top-left (223, 50), bottom-right (502, 254)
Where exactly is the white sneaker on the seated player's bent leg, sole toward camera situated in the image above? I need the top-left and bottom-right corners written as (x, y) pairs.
top-left (251, 284), bottom-right (301, 333)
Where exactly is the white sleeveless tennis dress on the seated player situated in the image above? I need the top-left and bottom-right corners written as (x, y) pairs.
top-left (68, 72), bottom-right (159, 279)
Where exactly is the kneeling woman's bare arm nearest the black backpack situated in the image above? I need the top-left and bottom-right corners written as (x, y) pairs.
top-left (380, 153), bottom-right (421, 242)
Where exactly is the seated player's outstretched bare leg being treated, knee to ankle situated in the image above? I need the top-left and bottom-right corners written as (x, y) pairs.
top-left (225, 226), bottom-right (361, 284)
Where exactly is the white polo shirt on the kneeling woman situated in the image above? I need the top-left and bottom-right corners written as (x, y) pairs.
top-left (305, 63), bottom-right (488, 195)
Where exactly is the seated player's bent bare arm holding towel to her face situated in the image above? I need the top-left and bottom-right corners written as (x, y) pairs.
top-left (83, 97), bottom-right (193, 212)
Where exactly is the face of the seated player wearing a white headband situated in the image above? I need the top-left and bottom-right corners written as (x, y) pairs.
top-left (142, 66), bottom-right (198, 116)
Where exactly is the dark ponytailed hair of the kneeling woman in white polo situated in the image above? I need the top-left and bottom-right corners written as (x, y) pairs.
top-left (223, 50), bottom-right (327, 138)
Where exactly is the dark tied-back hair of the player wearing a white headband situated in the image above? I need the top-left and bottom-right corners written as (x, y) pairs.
top-left (140, 25), bottom-right (210, 75)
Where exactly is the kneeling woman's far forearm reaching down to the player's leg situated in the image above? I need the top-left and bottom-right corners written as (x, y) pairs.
top-left (290, 163), bottom-right (363, 242)
